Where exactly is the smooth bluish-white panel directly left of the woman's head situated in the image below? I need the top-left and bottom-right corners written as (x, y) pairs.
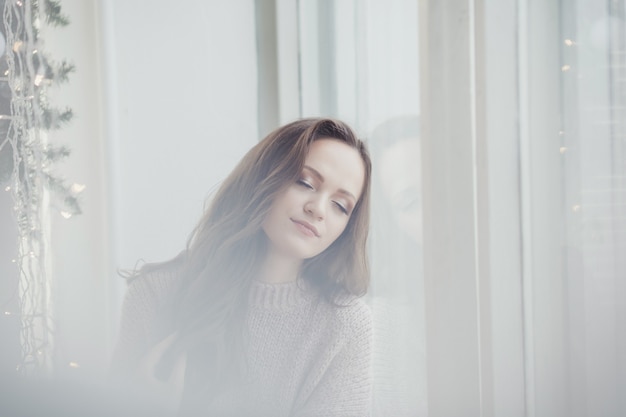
top-left (103, 0), bottom-right (258, 267)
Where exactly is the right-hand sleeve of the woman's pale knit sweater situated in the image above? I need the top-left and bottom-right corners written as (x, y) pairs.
top-left (294, 306), bottom-right (372, 417)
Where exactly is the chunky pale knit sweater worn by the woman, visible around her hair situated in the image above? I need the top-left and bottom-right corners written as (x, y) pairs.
top-left (112, 264), bottom-right (372, 417)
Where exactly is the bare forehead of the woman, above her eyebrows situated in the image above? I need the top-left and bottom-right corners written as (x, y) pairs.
top-left (305, 138), bottom-right (365, 199)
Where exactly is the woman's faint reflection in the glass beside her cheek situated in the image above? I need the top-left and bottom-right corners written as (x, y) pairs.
top-left (370, 115), bottom-right (426, 416)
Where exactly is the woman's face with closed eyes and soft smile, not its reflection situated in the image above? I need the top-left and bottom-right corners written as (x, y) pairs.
top-left (263, 139), bottom-right (365, 260)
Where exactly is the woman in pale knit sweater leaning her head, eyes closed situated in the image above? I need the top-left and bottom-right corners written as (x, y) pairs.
top-left (113, 119), bottom-right (371, 417)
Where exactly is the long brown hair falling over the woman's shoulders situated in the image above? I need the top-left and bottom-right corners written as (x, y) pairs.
top-left (140, 119), bottom-right (371, 400)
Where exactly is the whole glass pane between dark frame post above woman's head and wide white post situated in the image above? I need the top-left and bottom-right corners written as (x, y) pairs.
top-left (299, 0), bottom-right (427, 416)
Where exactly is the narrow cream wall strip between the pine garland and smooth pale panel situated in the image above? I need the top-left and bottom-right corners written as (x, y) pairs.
top-left (42, 0), bottom-right (112, 373)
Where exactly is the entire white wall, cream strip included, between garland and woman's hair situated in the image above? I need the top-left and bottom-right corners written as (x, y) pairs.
top-left (45, 0), bottom-right (258, 372)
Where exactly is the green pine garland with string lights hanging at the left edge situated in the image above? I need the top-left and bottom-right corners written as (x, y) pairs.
top-left (0, 0), bottom-right (76, 373)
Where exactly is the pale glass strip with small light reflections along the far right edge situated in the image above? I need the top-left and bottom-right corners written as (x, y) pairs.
top-left (560, 0), bottom-right (626, 416)
